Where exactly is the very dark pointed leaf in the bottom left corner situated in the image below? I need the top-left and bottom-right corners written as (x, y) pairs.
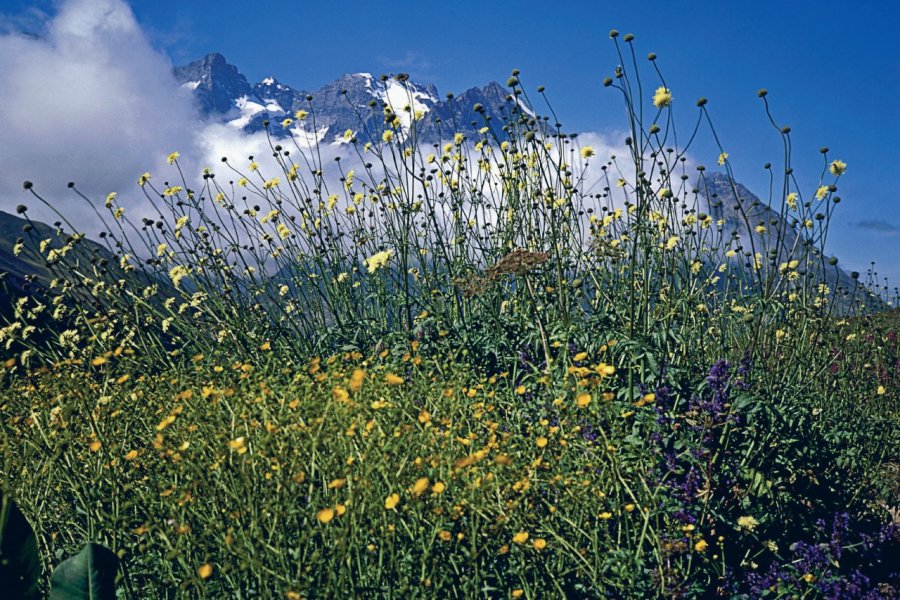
top-left (0, 492), bottom-right (41, 599)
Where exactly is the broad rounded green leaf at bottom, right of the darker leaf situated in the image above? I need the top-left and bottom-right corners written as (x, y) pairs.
top-left (50, 542), bottom-right (119, 600)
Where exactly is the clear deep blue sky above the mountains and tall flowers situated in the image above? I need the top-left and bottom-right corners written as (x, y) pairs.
top-left (0, 0), bottom-right (900, 285)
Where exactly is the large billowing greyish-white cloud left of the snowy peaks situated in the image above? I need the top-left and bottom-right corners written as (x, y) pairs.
top-left (0, 0), bottom-right (198, 230)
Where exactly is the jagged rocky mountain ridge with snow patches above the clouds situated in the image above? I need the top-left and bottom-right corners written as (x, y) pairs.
top-left (175, 54), bottom-right (534, 145)
